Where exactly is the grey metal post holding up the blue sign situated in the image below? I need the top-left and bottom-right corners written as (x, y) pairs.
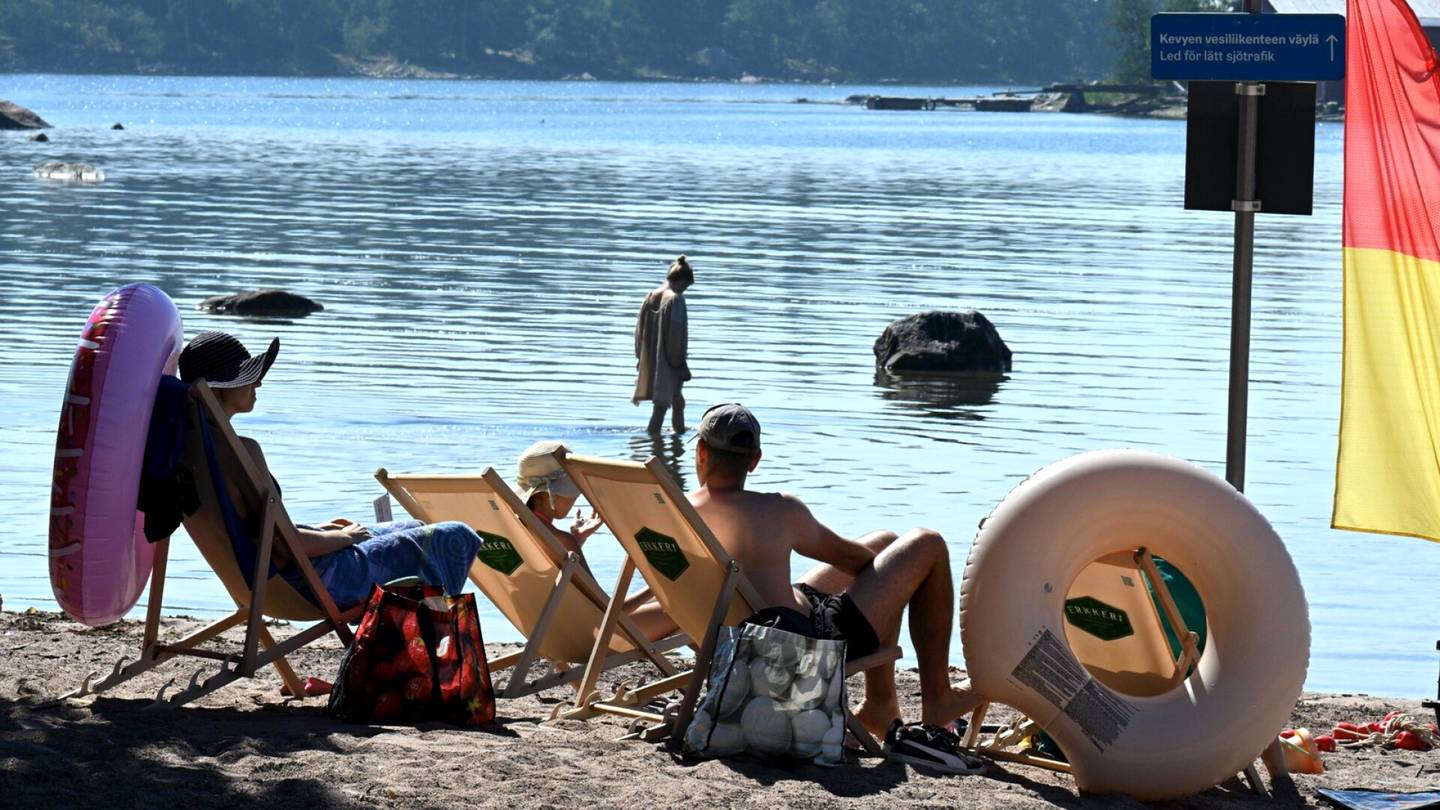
top-left (1225, 0), bottom-right (1264, 491)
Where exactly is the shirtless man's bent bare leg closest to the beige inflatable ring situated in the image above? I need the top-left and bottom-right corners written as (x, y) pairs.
top-left (848, 529), bottom-right (978, 725)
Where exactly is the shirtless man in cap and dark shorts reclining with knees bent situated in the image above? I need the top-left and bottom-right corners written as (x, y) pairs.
top-left (665, 404), bottom-right (976, 735)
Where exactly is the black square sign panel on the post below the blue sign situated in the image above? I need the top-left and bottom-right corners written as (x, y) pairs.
top-left (1185, 82), bottom-right (1315, 216)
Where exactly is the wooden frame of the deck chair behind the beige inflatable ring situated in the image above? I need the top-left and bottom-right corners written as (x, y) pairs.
top-left (962, 546), bottom-right (1267, 794)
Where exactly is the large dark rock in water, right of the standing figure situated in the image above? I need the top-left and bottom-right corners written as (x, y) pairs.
top-left (876, 310), bottom-right (1009, 373)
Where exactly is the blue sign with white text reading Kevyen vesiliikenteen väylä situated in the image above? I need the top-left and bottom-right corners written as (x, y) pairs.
top-left (1151, 13), bottom-right (1345, 82)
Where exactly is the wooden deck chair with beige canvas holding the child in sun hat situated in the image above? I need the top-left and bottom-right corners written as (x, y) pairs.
top-left (374, 468), bottom-right (688, 698)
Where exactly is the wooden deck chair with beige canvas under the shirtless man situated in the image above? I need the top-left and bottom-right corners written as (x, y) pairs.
top-left (557, 454), bottom-right (900, 757)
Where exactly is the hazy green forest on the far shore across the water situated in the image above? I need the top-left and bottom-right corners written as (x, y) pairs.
top-left (0, 0), bottom-right (1225, 84)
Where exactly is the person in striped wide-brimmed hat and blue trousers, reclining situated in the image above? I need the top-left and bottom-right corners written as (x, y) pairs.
top-left (180, 331), bottom-right (481, 610)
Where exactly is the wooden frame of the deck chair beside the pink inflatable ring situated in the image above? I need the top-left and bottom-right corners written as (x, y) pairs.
top-left (60, 380), bottom-right (364, 706)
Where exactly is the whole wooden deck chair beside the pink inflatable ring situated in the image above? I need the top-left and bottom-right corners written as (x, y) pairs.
top-left (62, 380), bottom-right (364, 705)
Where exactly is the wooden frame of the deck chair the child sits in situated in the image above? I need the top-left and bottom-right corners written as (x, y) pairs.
top-left (374, 467), bottom-right (690, 699)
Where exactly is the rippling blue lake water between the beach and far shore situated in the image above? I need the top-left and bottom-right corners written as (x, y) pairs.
top-left (0, 75), bottom-right (1440, 696)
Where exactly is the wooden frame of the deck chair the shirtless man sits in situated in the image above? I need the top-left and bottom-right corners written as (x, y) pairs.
top-left (554, 454), bottom-right (900, 757)
